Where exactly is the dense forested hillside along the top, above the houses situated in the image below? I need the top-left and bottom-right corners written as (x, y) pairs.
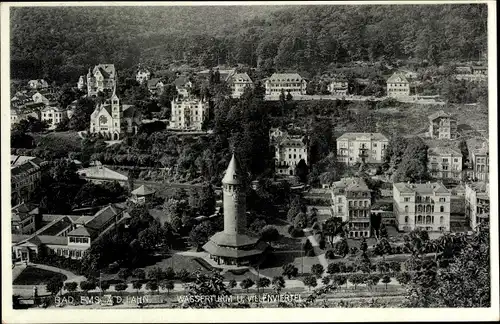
top-left (11, 4), bottom-right (487, 82)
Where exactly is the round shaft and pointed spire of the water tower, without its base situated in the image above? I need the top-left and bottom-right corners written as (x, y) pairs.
top-left (222, 153), bottom-right (247, 235)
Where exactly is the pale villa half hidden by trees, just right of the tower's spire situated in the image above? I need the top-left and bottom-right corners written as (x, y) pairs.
top-left (269, 128), bottom-right (308, 176)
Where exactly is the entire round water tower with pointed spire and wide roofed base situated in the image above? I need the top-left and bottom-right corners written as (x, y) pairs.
top-left (203, 153), bottom-right (268, 266)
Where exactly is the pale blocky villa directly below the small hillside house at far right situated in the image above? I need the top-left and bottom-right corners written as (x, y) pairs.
top-left (427, 147), bottom-right (462, 181)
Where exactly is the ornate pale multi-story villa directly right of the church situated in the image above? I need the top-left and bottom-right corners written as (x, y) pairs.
top-left (170, 97), bottom-right (209, 130)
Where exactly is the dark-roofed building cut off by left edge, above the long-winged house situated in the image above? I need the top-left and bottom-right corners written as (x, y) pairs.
top-left (10, 156), bottom-right (44, 206)
